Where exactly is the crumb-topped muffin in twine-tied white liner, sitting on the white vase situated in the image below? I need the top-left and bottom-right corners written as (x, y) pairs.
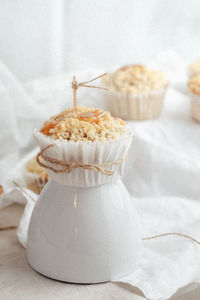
top-left (35, 106), bottom-right (132, 187)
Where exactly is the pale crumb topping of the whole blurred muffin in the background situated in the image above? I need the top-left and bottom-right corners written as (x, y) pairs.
top-left (104, 65), bottom-right (168, 94)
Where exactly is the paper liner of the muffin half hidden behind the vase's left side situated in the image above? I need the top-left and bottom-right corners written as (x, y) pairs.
top-left (24, 171), bottom-right (47, 194)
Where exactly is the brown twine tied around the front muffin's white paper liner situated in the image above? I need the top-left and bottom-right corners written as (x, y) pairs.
top-left (36, 144), bottom-right (127, 176)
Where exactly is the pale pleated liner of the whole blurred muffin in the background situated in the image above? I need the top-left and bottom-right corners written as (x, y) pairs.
top-left (106, 88), bottom-right (167, 120)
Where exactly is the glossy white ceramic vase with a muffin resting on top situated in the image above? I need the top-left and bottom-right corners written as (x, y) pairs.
top-left (27, 179), bottom-right (142, 283)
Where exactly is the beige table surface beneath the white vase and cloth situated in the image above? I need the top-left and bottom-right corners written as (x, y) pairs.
top-left (0, 204), bottom-right (200, 300)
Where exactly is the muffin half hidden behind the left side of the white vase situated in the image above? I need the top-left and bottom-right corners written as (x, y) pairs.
top-left (24, 157), bottom-right (49, 194)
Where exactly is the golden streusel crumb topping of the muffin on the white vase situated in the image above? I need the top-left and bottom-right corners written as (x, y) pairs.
top-left (40, 106), bottom-right (127, 142)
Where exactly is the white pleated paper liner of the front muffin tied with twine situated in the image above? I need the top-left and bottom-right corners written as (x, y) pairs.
top-left (34, 130), bottom-right (132, 187)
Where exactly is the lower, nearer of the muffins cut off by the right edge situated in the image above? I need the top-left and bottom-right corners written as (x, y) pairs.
top-left (188, 73), bottom-right (200, 123)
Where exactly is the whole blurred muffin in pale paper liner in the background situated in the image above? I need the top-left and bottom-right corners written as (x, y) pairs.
top-left (104, 65), bottom-right (168, 120)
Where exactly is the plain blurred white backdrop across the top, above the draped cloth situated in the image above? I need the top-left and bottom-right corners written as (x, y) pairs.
top-left (0, 0), bottom-right (200, 81)
